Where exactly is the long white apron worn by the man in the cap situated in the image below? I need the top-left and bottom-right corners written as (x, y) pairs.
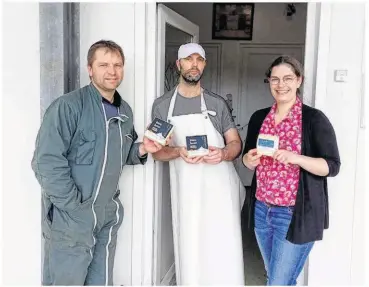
top-left (168, 87), bottom-right (245, 285)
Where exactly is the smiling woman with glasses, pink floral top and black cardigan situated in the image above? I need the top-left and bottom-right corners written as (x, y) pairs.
top-left (243, 56), bottom-right (340, 285)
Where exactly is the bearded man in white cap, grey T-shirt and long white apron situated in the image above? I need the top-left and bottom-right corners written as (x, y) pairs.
top-left (152, 43), bottom-right (245, 285)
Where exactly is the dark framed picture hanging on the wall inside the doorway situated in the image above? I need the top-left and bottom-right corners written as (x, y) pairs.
top-left (213, 3), bottom-right (255, 40)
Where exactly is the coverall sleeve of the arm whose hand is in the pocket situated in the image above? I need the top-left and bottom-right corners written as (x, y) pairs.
top-left (31, 99), bottom-right (81, 210)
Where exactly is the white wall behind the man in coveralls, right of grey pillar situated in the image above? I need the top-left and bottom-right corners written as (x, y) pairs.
top-left (80, 3), bottom-right (150, 285)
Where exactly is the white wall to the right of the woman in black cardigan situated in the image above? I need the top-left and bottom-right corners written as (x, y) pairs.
top-left (309, 3), bottom-right (366, 285)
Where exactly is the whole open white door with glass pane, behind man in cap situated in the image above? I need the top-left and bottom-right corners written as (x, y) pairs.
top-left (153, 4), bottom-right (199, 285)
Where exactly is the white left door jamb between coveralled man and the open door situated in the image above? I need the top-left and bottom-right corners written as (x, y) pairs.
top-left (136, 2), bottom-right (157, 286)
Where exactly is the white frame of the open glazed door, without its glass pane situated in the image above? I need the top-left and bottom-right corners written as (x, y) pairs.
top-left (152, 4), bottom-right (199, 285)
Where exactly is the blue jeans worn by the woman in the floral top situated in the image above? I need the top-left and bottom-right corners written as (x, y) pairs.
top-left (255, 200), bottom-right (314, 285)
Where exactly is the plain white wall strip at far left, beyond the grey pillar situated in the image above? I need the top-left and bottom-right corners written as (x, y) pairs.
top-left (1, 2), bottom-right (41, 285)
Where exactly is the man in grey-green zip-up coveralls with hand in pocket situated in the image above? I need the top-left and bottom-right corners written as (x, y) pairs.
top-left (32, 40), bottom-right (161, 285)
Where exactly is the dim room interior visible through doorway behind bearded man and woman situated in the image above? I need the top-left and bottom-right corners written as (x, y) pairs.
top-left (154, 2), bottom-right (307, 285)
